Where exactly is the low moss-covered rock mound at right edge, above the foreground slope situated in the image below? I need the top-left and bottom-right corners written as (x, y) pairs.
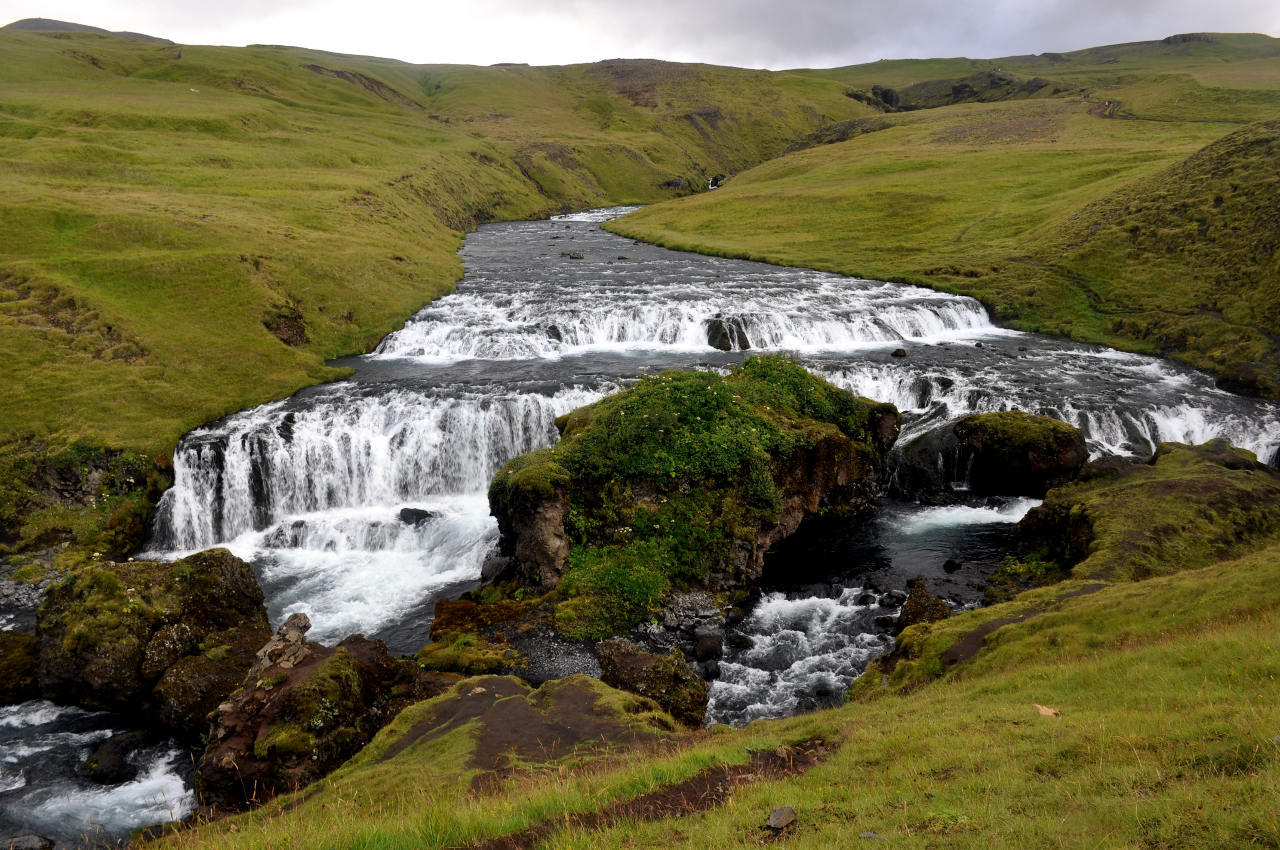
top-left (1018, 439), bottom-right (1280, 579)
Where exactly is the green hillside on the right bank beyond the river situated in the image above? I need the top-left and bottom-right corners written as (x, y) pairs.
top-left (612, 36), bottom-right (1280, 396)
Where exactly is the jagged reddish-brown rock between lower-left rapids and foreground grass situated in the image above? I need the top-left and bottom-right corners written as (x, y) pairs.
top-left (196, 614), bottom-right (448, 810)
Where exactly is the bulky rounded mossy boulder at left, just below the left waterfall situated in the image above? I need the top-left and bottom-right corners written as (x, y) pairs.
top-left (36, 549), bottom-right (271, 737)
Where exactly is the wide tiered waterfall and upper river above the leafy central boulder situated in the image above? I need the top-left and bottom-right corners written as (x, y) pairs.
top-left (142, 202), bottom-right (1280, 701)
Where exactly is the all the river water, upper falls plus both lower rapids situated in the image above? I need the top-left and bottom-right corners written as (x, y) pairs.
top-left (10, 209), bottom-right (1280, 837)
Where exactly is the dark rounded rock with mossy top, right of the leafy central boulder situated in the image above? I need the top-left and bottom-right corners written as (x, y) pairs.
top-left (893, 411), bottom-right (1089, 501)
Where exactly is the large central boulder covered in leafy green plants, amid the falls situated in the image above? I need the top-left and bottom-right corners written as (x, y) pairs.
top-left (489, 356), bottom-right (899, 638)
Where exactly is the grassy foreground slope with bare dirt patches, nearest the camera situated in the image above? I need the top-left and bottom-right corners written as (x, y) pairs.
top-left (164, 545), bottom-right (1280, 849)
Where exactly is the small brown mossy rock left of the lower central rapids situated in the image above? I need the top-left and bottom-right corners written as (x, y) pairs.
top-left (595, 638), bottom-right (708, 727)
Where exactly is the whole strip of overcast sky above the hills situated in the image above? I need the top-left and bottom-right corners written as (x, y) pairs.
top-left (0, 0), bottom-right (1280, 69)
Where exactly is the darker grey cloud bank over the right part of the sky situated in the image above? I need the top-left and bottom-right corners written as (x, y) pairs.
top-left (471, 0), bottom-right (1280, 68)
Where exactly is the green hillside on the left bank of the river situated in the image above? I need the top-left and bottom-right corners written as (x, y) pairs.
top-left (0, 31), bottom-right (865, 451)
